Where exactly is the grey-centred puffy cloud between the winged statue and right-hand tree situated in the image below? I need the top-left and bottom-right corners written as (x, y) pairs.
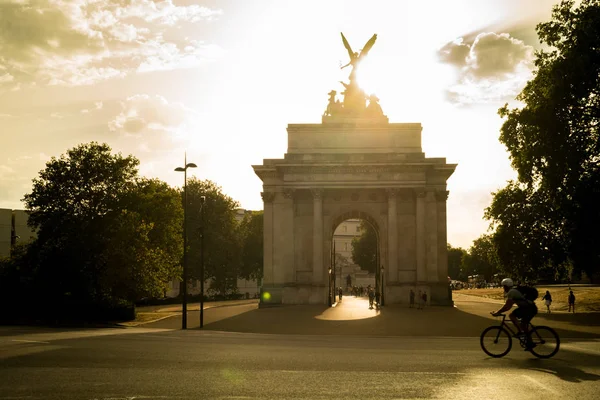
top-left (438, 32), bottom-right (534, 104)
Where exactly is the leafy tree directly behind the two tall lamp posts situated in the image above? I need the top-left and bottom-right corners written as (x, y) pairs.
top-left (187, 178), bottom-right (241, 295)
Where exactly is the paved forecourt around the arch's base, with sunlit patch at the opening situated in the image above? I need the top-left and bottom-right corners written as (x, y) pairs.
top-left (139, 294), bottom-right (600, 338)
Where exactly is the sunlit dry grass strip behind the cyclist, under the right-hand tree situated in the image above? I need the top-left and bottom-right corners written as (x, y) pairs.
top-left (457, 286), bottom-right (600, 312)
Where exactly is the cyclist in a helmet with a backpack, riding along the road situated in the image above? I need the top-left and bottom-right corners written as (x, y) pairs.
top-left (492, 278), bottom-right (537, 350)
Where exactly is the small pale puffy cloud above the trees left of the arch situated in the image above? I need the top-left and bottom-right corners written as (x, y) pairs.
top-left (108, 94), bottom-right (198, 152)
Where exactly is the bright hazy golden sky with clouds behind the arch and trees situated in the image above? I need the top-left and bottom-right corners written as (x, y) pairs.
top-left (0, 0), bottom-right (557, 248)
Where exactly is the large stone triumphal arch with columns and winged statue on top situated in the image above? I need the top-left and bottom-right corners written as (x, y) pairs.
top-left (253, 35), bottom-right (456, 306)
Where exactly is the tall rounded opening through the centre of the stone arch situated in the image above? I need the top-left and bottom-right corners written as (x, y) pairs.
top-left (329, 211), bottom-right (383, 310)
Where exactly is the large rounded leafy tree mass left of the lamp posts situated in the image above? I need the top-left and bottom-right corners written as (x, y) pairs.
top-left (24, 142), bottom-right (181, 307)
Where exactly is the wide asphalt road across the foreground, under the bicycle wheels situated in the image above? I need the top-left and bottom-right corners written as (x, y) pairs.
top-left (0, 327), bottom-right (600, 400)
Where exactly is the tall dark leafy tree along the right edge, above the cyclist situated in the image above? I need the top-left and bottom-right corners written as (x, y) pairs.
top-left (486, 0), bottom-right (600, 277)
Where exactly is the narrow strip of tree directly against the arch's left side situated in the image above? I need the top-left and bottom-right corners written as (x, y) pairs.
top-left (238, 211), bottom-right (264, 280)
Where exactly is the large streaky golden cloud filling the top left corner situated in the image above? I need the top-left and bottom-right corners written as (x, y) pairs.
top-left (0, 0), bottom-right (221, 89)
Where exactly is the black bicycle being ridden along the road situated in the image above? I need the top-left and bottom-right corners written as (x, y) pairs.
top-left (480, 313), bottom-right (560, 358)
